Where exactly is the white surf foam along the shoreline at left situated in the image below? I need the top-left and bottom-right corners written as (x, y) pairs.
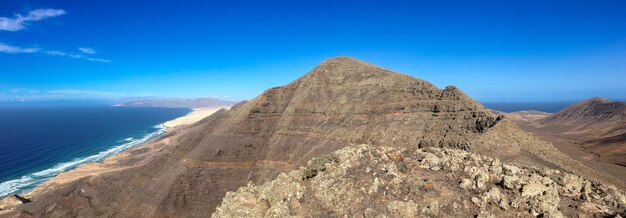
top-left (0, 124), bottom-right (165, 198)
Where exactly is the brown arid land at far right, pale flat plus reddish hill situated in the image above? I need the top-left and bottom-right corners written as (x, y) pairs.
top-left (497, 97), bottom-right (626, 186)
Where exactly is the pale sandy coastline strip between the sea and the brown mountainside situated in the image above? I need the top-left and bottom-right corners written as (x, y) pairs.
top-left (0, 106), bottom-right (230, 215)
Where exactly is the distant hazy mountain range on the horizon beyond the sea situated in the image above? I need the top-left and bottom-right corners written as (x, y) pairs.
top-left (114, 98), bottom-right (237, 108)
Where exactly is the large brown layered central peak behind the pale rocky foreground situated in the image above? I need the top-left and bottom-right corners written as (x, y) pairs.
top-left (0, 57), bottom-right (624, 217)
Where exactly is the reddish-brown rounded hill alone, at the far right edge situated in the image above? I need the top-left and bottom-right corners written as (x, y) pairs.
top-left (525, 97), bottom-right (626, 170)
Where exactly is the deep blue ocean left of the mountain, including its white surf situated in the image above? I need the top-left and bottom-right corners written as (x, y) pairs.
top-left (0, 104), bottom-right (191, 198)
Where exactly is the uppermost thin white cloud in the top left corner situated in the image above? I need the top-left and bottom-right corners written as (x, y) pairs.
top-left (0, 9), bottom-right (65, 31)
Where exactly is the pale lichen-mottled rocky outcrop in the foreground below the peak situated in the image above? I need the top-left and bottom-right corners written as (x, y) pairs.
top-left (213, 144), bottom-right (626, 217)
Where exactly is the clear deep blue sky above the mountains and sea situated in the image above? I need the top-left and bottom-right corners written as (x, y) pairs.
top-left (0, 0), bottom-right (626, 102)
